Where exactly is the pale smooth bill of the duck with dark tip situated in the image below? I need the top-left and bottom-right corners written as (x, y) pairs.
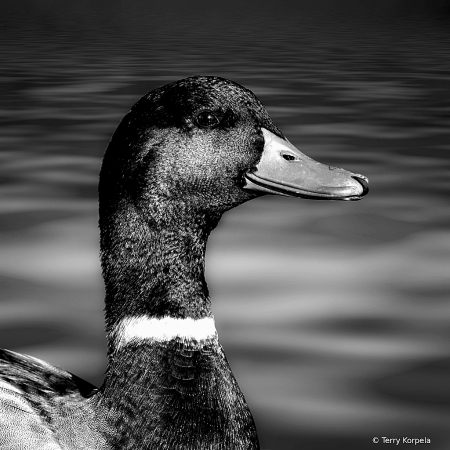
top-left (244, 128), bottom-right (369, 200)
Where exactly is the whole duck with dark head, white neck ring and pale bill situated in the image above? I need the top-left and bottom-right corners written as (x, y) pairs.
top-left (0, 76), bottom-right (368, 450)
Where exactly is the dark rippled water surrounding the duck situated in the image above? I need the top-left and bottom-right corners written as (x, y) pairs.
top-left (0, 0), bottom-right (450, 450)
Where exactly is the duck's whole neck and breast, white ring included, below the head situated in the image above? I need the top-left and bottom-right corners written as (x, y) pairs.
top-left (96, 199), bottom-right (259, 450)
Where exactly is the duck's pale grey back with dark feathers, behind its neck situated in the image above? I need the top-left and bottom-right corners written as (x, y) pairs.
top-left (0, 350), bottom-right (107, 450)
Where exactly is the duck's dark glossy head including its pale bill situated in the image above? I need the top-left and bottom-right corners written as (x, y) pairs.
top-left (99, 76), bottom-right (368, 225)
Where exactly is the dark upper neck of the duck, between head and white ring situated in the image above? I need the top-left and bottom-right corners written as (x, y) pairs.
top-left (100, 200), bottom-right (220, 350)
